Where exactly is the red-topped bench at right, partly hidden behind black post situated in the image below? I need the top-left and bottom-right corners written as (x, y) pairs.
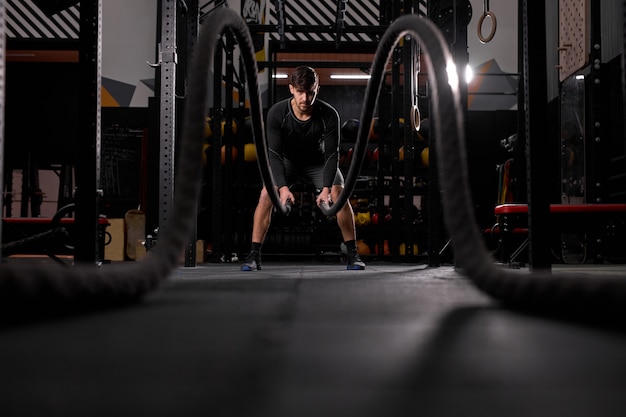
top-left (494, 203), bottom-right (626, 264)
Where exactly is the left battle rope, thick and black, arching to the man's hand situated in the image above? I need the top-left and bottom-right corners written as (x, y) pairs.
top-left (0, 8), bottom-right (288, 311)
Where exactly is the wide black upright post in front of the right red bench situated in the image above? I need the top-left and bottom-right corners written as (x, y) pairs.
top-left (521, 0), bottom-right (554, 270)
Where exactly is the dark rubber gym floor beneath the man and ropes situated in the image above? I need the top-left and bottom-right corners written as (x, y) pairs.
top-left (0, 259), bottom-right (626, 417)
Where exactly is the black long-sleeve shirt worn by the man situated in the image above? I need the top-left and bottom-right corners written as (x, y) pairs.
top-left (267, 98), bottom-right (340, 188)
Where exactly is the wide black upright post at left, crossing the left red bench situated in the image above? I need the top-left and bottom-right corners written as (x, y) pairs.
top-left (74, 0), bottom-right (102, 264)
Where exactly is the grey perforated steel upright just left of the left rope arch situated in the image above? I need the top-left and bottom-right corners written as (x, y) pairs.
top-left (158, 0), bottom-right (178, 232)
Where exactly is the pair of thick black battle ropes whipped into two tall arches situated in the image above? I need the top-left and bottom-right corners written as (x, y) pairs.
top-left (0, 8), bottom-right (626, 318)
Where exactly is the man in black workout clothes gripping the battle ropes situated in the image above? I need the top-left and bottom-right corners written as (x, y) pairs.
top-left (241, 66), bottom-right (365, 271)
